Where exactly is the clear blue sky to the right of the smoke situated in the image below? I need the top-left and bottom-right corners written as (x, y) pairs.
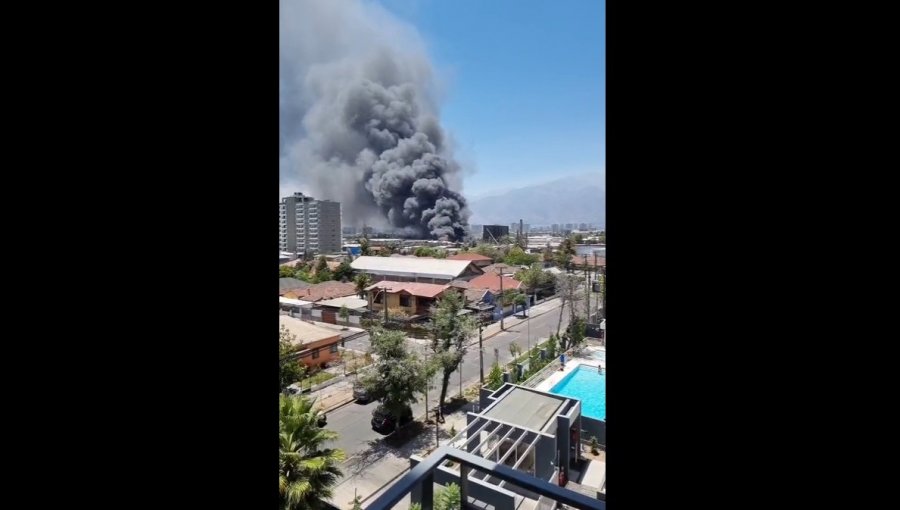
top-left (379, 0), bottom-right (606, 198)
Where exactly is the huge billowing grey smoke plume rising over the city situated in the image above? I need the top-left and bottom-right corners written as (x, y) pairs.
top-left (279, 0), bottom-right (470, 239)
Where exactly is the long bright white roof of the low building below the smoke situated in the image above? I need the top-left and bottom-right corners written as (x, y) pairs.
top-left (350, 256), bottom-right (484, 285)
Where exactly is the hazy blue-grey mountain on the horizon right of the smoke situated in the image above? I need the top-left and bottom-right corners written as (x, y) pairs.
top-left (469, 174), bottom-right (606, 226)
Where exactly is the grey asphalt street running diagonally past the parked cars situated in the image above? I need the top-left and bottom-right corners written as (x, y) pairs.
top-left (328, 308), bottom-right (569, 458)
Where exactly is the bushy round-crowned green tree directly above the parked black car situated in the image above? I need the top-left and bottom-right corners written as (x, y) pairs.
top-left (360, 328), bottom-right (428, 427)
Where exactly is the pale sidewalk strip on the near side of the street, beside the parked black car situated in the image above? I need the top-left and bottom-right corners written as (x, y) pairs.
top-left (331, 404), bottom-right (471, 510)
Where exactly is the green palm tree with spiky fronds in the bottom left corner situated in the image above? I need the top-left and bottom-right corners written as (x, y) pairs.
top-left (278, 395), bottom-right (344, 510)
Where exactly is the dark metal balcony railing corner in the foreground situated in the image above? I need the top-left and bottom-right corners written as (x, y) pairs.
top-left (366, 446), bottom-right (606, 510)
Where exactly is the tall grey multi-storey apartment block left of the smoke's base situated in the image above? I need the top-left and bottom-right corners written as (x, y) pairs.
top-left (278, 193), bottom-right (341, 254)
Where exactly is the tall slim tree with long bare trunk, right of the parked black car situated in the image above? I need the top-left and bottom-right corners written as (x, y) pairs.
top-left (430, 292), bottom-right (478, 421)
